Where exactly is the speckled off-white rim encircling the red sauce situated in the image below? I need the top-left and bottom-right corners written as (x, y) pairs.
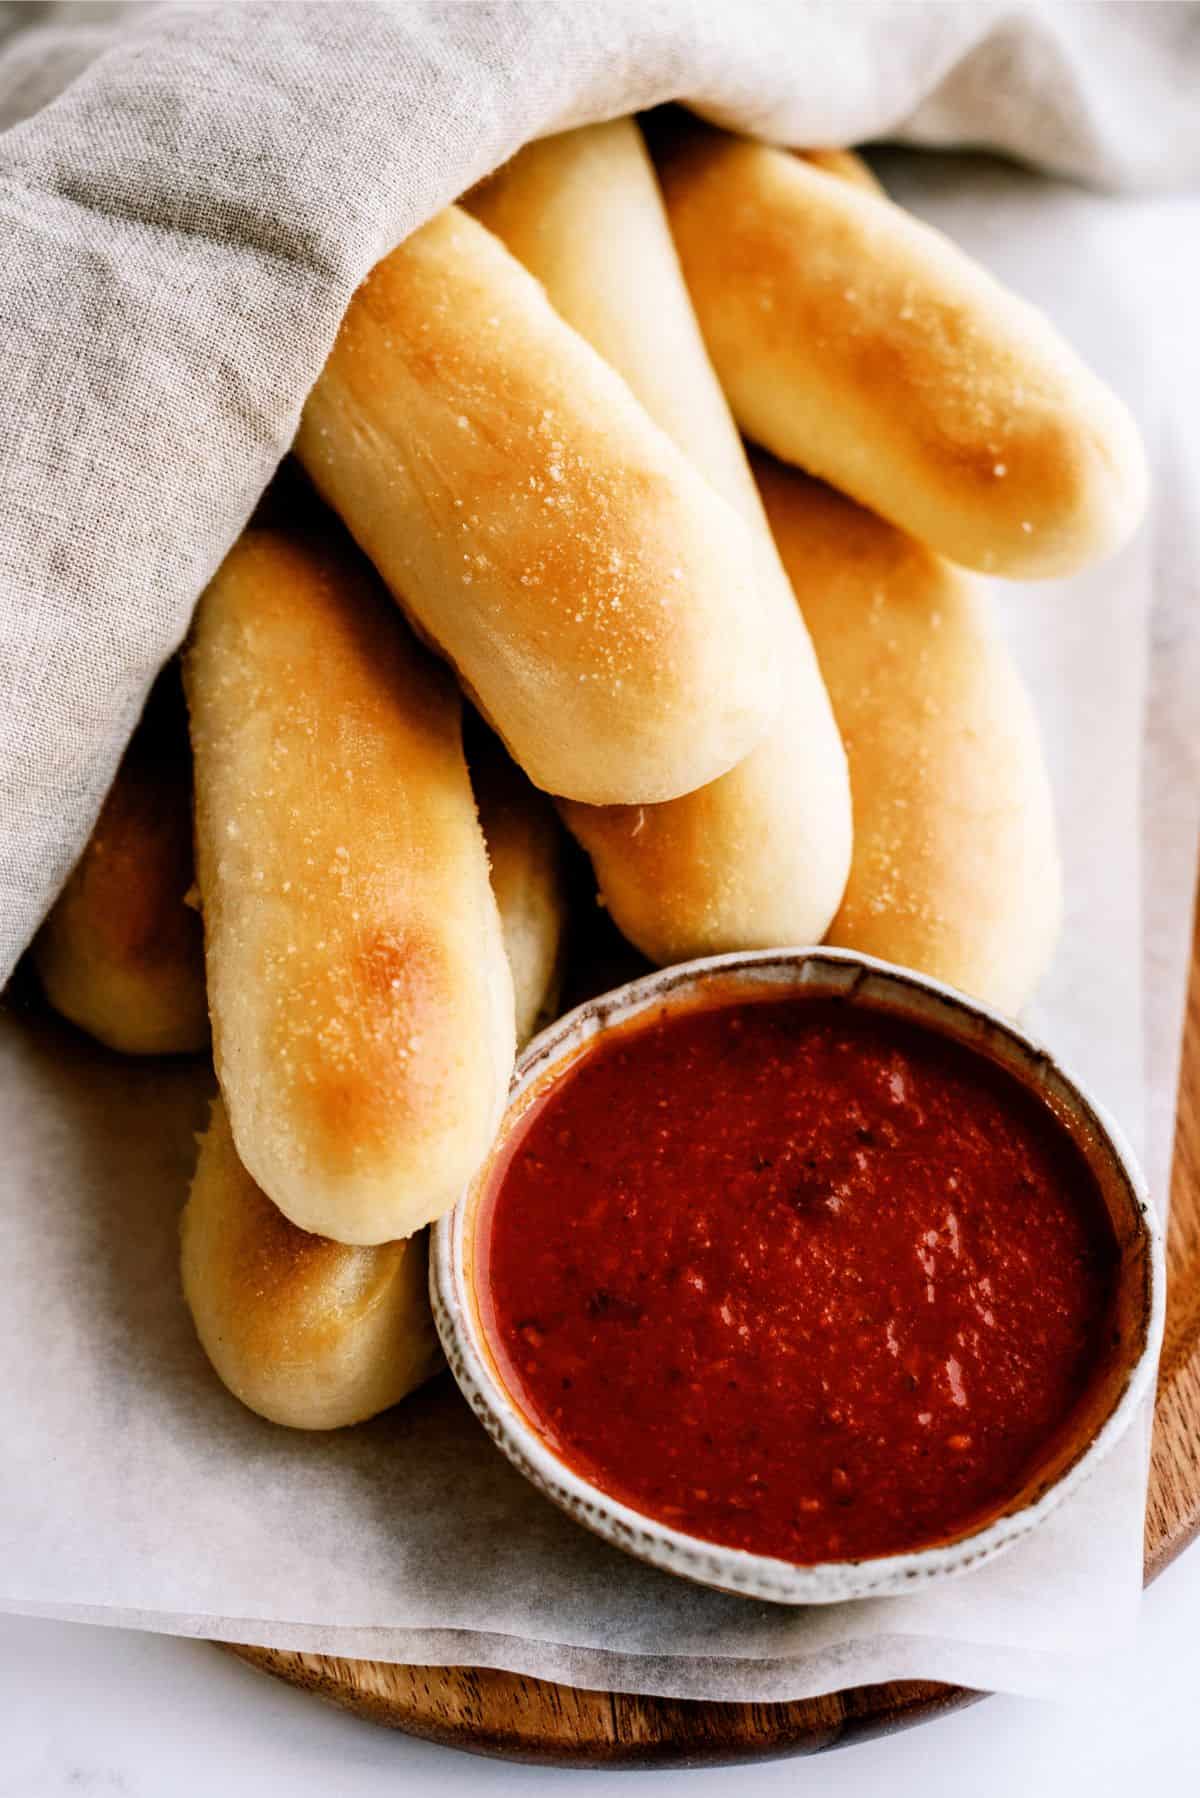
top-left (430, 948), bottom-right (1166, 1604)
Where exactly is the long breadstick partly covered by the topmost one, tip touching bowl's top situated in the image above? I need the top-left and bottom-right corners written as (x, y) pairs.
top-left (468, 119), bottom-right (851, 962)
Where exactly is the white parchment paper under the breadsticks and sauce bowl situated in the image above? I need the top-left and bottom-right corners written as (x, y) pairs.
top-left (0, 156), bottom-right (1200, 1699)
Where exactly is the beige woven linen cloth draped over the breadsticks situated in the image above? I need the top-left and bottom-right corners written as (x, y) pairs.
top-left (0, 0), bottom-right (1200, 984)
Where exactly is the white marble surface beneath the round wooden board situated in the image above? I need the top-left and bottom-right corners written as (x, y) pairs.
top-left (0, 1546), bottom-right (1200, 1798)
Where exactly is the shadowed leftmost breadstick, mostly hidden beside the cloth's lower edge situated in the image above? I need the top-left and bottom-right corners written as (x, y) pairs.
top-left (32, 667), bottom-right (209, 1055)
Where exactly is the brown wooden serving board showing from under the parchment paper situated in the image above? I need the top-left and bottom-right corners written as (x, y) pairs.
top-left (234, 891), bottom-right (1200, 1766)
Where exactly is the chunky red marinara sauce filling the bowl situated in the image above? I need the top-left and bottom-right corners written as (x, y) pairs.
top-left (480, 998), bottom-right (1117, 1562)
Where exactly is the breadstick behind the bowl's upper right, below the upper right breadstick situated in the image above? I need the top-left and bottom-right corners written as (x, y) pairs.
top-left (754, 457), bottom-right (1060, 1012)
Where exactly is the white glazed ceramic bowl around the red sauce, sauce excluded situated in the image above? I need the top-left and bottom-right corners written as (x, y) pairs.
top-left (430, 949), bottom-right (1166, 1604)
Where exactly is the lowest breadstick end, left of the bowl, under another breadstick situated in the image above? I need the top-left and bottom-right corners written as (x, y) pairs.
top-left (180, 1099), bottom-right (443, 1429)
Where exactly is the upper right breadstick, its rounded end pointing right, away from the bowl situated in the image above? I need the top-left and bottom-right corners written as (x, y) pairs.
top-left (655, 120), bottom-right (1146, 577)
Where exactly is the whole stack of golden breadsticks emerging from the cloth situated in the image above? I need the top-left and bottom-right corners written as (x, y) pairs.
top-left (34, 113), bottom-right (1146, 1428)
